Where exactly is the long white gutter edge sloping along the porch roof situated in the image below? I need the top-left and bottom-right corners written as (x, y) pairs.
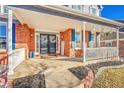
top-left (42, 5), bottom-right (124, 26)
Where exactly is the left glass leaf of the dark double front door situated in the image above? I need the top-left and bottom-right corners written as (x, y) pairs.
top-left (40, 34), bottom-right (48, 54)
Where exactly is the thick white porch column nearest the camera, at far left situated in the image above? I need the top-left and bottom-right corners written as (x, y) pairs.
top-left (7, 10), bottom-right (13, 74)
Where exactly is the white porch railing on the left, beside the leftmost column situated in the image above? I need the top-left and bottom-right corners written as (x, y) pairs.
top-left (8, 48), bottom-right (25, 72)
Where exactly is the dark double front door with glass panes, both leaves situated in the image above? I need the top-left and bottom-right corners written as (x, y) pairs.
top-left (40, 34), bottom-right (56, 54)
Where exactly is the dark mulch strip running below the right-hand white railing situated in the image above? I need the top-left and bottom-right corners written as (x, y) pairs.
top-left (87, 61), bottom-right (124, 74)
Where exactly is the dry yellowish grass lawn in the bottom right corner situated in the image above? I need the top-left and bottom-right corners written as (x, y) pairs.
top-left (93, 67), bottom-right (124, 88)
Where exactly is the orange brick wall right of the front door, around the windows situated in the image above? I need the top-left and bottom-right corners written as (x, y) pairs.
top-left (60, 28), bottom-right (89, 57)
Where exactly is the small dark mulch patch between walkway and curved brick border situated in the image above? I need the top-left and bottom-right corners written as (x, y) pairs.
top-left (68, 66), bottom-right (88, 80)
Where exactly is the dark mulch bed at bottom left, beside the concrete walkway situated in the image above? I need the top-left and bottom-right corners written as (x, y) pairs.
top-left (13, 74), bottom-right (46, 88)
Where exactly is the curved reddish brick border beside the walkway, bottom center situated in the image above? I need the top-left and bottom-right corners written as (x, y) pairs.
top-left (75, 67), bottom-right (95, 88)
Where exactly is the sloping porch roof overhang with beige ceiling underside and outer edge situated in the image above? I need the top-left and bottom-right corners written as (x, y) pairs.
top-left (9, 5), bottom-right (124, 31)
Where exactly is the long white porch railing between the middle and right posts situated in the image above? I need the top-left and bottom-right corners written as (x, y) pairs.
top-left (86, 47), bottom-right (117, 60)
